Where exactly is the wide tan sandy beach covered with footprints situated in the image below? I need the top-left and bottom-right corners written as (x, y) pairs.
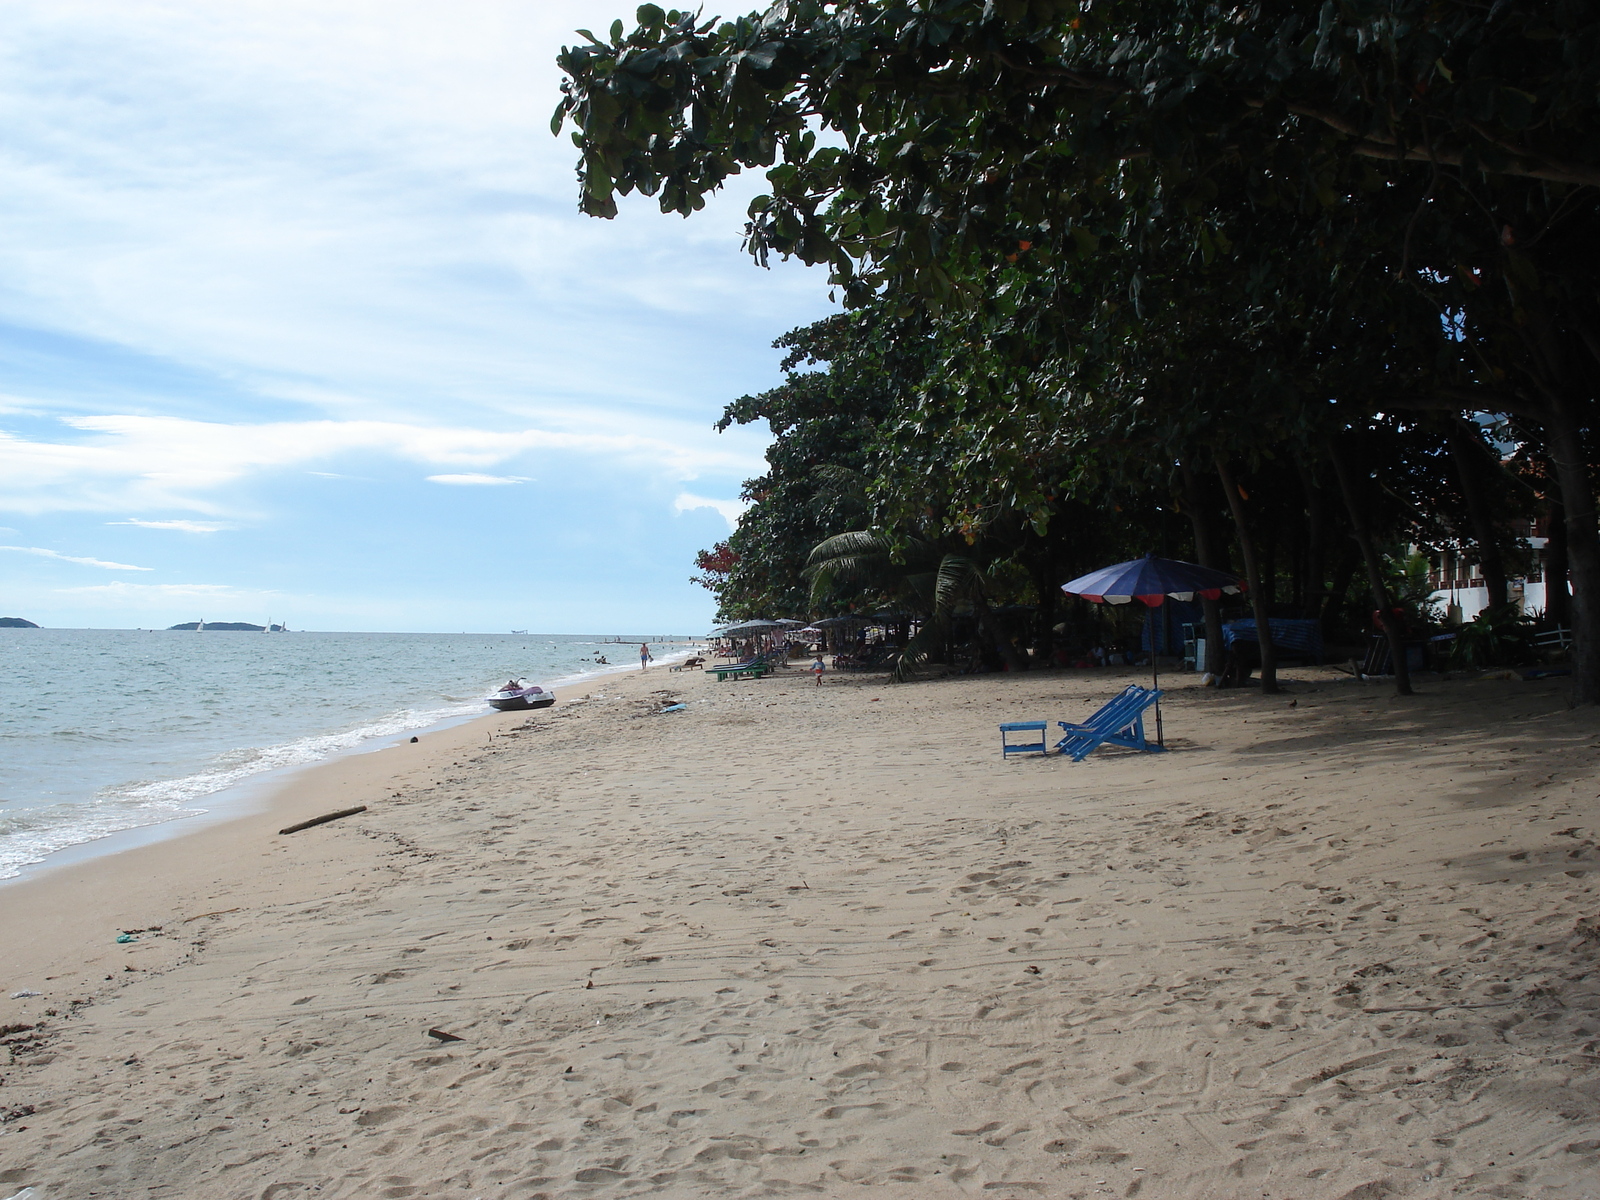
top-left (0, 666), bottom-right (1600, 1200)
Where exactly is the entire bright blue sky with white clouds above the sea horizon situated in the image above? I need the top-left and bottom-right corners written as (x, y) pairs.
top-left (0, 0), bottom-right (830, 634)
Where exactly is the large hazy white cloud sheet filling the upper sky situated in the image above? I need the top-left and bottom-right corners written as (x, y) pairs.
top-left (0, 0), bottom-right (826, 424)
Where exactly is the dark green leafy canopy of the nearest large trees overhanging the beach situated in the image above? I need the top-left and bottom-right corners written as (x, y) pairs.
top-left (555, 0), bottom-right (1600, 702)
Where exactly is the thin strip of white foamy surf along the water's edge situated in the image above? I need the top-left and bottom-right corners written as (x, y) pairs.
top-left (0, 649), bottom-right (696, 894)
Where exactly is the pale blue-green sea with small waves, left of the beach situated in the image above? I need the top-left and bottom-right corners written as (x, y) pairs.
top-left (0, 629), bottom-right (690, 880)
